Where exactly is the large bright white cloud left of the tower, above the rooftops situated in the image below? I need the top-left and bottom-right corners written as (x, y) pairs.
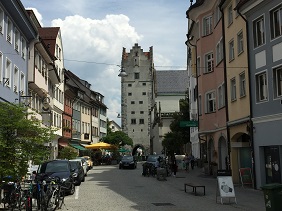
top-left (49, 14), bottom-right (143, 121)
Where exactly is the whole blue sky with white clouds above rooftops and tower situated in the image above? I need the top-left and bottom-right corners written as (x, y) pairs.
top-left (21, 0), bottom-right (190, 124)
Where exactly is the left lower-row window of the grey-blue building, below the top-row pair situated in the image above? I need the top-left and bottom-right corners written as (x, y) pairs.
top-left (256, 72), bottom-right (268, 102)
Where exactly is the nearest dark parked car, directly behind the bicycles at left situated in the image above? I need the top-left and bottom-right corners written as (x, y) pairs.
top-left (35, 160), bottom-right (75, 195)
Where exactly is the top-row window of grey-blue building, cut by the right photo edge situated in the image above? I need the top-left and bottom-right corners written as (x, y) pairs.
top-left (270, 5), bottom-right (282, 39)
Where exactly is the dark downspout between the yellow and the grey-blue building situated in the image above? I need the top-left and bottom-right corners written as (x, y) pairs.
top-left (235, 7), bottom-right (257, 189)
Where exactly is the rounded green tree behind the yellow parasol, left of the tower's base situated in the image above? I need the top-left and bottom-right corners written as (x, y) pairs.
top-left (102, 131), bottom-right (133, 149)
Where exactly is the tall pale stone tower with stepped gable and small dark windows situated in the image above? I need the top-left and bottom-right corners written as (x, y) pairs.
top-left (121, 44), bottom-right (158, 154)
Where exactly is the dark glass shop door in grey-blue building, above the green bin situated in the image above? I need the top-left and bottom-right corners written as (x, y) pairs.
top-left (264, 146), bottom-right (281, 184)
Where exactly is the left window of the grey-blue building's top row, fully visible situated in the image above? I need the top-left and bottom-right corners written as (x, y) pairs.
top-left (253, 16), bottom-right (265, 48)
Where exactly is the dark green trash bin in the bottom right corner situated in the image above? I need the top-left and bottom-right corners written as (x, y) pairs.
top-left (261, 183), bottom-right (282, 211)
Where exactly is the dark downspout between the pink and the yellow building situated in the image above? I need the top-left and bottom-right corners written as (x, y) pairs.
top-left (218, 0), bottom-right (232, 171)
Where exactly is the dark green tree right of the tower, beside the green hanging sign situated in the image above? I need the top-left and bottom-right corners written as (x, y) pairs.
top-left (162, 99), bottom-right (190, 154)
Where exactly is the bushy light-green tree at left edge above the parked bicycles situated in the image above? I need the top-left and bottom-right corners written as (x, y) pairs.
top-left (0, 102), bottom-right (54, 181)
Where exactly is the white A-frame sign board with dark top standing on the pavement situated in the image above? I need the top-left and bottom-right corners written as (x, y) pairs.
top-left (216, 170), bottom-right (237, 204)
